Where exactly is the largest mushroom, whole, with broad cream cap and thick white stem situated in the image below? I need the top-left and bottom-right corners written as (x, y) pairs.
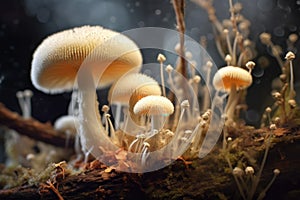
top-left (31, 26), bottom-right (142, 157)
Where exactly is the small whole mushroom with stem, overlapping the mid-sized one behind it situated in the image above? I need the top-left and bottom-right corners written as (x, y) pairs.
top-left (133, 95), bottom-right (174, 133)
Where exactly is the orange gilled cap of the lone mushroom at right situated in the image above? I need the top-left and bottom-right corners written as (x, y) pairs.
top-left (213, 66), bottom-right (252, 92)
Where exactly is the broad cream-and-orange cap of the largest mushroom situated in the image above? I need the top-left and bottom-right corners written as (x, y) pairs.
top-left (31, 26), bottom-right (142, 93)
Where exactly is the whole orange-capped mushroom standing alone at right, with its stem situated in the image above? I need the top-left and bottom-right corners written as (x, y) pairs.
top-left (213, 66), bottom-right (252, 120)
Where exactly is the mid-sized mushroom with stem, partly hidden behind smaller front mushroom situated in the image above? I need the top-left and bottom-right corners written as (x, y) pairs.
top-left (108, 73), bottom-right (161, 129)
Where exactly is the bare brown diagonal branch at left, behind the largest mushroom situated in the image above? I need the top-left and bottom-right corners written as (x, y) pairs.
top-left (0, 103), bottom-right (74, 147)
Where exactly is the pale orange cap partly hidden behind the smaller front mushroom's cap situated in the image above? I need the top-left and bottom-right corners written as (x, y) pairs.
top-left (108, 73), bottom-right (161, 104)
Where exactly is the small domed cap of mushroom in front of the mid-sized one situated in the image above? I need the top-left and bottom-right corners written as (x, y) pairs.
top-left (133, 95), bottom-right (174, 115)
